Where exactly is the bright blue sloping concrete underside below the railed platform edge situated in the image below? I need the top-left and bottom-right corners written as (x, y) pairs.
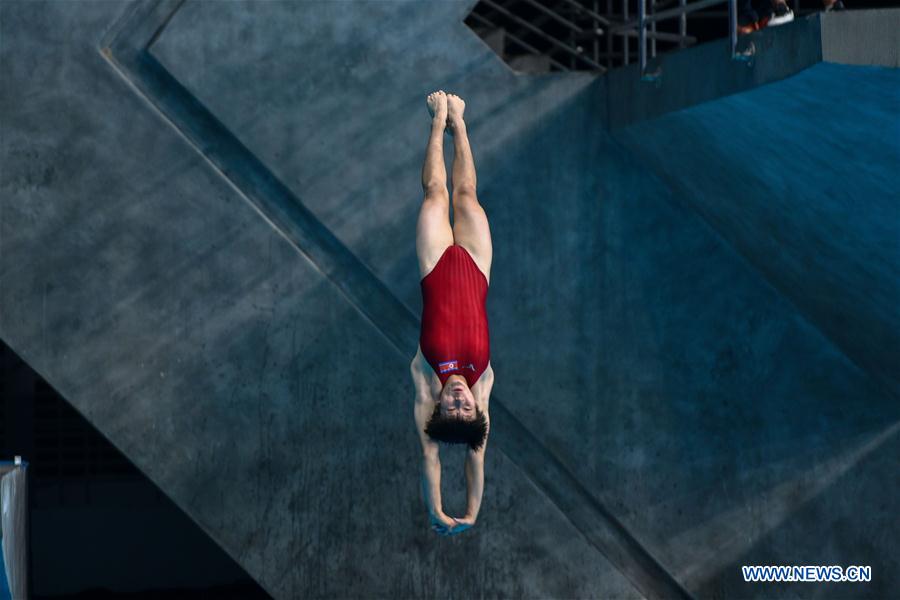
top-left (617, 63), bottom-right (900, 394)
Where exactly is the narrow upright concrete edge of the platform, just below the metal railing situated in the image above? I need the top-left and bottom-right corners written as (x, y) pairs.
top-left (603, 9), bottom-right (900, 130)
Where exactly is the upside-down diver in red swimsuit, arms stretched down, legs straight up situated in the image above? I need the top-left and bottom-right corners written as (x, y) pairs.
top-left (410, 90), bottom-right (494, 535)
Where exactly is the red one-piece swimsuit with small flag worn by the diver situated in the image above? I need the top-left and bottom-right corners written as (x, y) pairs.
top-left (419, 244), bottom-right (490, 388)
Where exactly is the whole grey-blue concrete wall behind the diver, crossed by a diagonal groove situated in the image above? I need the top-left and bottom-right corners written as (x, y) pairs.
top-left (0, 2), bottom-right (900, 598)
